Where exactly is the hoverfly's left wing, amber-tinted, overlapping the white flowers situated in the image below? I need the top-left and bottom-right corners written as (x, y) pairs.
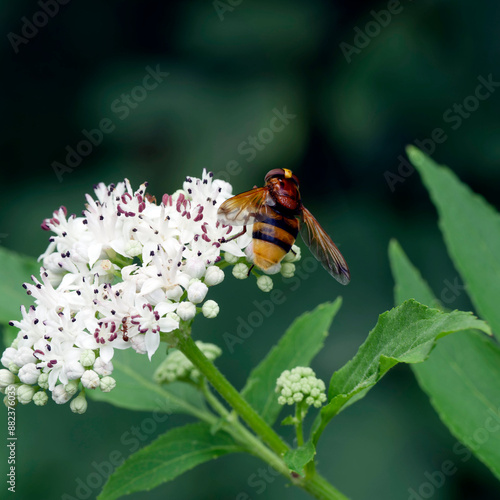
top-left (217, 187), bottom-right (272, 226)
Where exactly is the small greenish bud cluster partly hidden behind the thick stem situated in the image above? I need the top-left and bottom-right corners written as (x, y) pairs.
top-left (154, 340), bottom-right (222, 384)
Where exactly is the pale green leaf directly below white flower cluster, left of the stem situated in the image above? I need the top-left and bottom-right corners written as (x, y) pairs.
top-left (87, 349), bottom-right (204, 416)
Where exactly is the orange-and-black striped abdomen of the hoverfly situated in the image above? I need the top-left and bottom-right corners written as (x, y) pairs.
top-left (252, 213), bottom-right (299, 270)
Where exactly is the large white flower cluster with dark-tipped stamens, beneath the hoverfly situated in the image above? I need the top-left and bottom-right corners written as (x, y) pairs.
top-left (0, 171), bottom-right (251, 413)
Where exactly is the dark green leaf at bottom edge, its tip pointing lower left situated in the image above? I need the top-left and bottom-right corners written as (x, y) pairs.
top-left (98, 422), bottom-right (243, 500)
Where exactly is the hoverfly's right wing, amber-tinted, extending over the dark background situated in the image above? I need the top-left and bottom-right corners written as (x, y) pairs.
top-left (300, 207), bottom-right (351, 285)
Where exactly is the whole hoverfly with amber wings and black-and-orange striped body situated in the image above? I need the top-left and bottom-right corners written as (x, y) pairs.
top-left (217, 168), bottom-right (351, 285)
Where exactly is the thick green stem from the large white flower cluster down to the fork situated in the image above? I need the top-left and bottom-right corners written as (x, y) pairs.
top-left (176, 330), bottom-right (289, 456)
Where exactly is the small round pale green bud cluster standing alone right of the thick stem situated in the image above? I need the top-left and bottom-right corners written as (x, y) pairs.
top-left (276, 366), bottom-right (326, 408)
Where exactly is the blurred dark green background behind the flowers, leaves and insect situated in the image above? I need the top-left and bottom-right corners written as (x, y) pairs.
top-left (0, 0), bottom-right (500, 500)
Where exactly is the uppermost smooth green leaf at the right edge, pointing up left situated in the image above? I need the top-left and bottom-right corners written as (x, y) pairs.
top-left (407, 146), bottom-right (500, 339)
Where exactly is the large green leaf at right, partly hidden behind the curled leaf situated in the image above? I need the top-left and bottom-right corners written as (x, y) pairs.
top-left (389, 236), bottom-right (500, 478)
